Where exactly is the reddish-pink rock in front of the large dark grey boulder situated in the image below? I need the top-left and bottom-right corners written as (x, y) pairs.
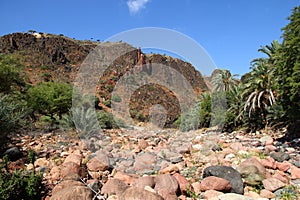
top-left (200, 176), bottom-right (231, 192)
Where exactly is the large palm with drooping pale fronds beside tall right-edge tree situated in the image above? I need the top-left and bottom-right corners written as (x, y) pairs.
top-left (242, 40), bottom-right (281, 125)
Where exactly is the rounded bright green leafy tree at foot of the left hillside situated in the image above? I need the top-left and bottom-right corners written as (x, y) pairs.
top-left (27, 82), bottom-right (72, 119)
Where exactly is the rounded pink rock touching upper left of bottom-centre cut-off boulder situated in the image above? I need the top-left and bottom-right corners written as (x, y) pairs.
top-left (101, 179), bottom-right (129, 196)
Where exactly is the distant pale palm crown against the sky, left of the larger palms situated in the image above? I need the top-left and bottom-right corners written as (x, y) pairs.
top-left (212, 69), bottom-right (239, 92)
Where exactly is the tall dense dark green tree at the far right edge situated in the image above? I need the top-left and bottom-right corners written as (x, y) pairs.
top-left (275, 6), bottom-right (300, 122)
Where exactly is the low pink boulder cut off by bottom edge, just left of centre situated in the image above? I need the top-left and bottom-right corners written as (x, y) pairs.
top-left (119, 187), bottom-right (164, 200)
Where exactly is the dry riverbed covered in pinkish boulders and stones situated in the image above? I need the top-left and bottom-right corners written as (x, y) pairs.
top-left (2, 127), bottom-right (300, 200)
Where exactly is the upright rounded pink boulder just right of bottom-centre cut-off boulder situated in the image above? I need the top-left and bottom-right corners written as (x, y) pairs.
top-left (154, 174), bottom-right (179, 198)
